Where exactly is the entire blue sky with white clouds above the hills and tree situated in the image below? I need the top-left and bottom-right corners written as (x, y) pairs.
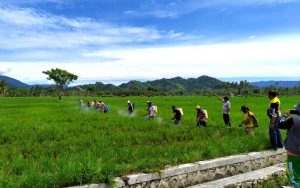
top-left (0, 0), bottom-right (300, 84)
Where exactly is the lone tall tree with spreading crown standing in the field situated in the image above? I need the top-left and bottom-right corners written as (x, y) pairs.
top-left (43, 68), bottom-right (78, 100)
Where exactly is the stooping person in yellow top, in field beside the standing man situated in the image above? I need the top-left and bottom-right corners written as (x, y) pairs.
top-left (239, 106), bottom-right (257, 135)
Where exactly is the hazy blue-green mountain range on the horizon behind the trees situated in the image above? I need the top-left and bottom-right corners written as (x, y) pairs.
top-left (0, 75), bottom-right (300, 91)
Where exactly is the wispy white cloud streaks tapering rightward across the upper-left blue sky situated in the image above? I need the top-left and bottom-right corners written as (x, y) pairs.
top-left (0, 6), bottom-right (184, 49)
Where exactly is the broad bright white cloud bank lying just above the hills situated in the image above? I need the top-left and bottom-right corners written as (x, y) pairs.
top-left (0, 35), bottom-right (300, 84)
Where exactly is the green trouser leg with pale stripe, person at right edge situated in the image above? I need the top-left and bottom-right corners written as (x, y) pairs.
top-left (286, 155), bottom-right (300, 188)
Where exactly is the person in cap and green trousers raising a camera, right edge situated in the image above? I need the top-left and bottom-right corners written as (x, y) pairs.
top-left (278, 102), bottom-right (300, 188)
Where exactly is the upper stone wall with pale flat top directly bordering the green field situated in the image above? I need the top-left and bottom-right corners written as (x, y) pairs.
top-left (68, 149), bottom-right (286, 188)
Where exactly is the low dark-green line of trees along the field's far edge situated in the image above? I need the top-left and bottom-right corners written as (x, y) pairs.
top-left (0, 80), bottom-right (300, 97)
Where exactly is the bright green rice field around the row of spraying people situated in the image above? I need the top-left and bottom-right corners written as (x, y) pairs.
top-left (0, 96), bottom-right (299, 188)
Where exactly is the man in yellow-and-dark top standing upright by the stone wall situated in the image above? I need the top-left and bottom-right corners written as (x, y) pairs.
top-left (267, 91), bottom-right (283, 150)
